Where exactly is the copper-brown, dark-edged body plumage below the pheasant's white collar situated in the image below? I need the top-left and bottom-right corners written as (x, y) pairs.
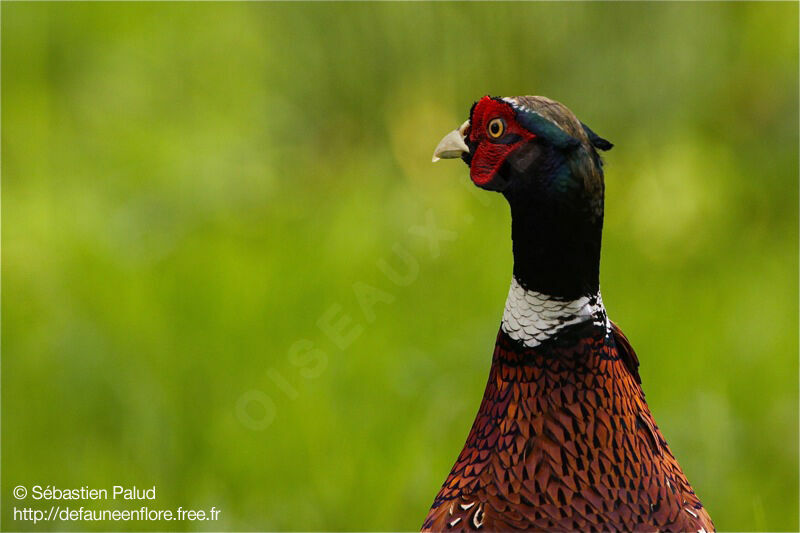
top-left (423, 326), bottom-right (713, 531)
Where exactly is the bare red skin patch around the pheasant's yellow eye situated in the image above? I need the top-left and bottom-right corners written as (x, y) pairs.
top-left (469, 96), bottom-right (536, 185)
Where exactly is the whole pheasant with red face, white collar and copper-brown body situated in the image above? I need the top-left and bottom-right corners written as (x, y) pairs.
top-left (422, 96), bottom-right (714, 532)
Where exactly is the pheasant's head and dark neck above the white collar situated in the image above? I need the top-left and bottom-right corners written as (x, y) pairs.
top-left (433, 96), bottom-right (613, 298)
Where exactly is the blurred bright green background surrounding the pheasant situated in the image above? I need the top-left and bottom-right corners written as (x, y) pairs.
top-left (0, 2), bottom-right (799, 531)
